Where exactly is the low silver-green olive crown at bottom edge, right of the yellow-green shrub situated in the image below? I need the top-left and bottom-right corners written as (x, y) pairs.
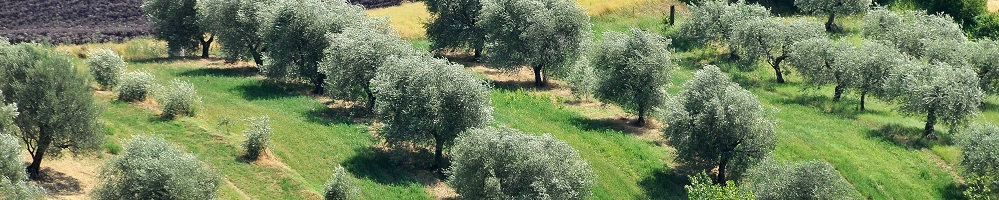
top-left (742, 160), bottom-right (861, 200)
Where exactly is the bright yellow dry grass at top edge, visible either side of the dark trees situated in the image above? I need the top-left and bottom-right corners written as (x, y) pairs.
top-left (367, 0), bottom-right (661, 39)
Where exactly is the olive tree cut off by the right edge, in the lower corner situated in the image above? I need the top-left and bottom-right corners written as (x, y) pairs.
top-left (958, 124), bottom-right (999, 198)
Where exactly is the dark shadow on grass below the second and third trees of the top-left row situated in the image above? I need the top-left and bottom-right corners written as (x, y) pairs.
top-left (230, 80), bottom-right (311, 101)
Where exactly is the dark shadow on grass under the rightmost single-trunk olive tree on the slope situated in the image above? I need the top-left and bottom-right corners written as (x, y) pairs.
top-left (867, 124), bottom-right (953, 149)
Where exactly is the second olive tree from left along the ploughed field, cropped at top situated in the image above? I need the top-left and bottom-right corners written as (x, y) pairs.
top-left (197, 0), bottom-right (274, 66)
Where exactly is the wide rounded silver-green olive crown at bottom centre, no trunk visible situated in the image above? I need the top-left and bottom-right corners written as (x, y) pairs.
top-left (446, 127), bottom-right (594, 199)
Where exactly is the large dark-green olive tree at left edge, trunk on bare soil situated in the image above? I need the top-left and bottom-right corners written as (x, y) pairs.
top-left (0, 44), bottom-right (104, 179)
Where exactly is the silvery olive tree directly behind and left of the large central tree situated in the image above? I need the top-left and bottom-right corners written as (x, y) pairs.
top-left (319, 23), bottom-right (414, 108)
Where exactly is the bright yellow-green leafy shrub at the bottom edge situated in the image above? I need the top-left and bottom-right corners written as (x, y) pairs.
top-left (683, 172), bottom-right (756, 200)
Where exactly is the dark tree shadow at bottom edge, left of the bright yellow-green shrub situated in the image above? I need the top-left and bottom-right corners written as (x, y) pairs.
top-left (638, 168), bottom-right (690, 199)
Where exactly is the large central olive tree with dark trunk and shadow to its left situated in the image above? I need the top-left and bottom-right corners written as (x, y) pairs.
top-left (371, 56), bottom-right (493, 167)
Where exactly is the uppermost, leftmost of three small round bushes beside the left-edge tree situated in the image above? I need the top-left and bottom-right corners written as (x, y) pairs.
top-left (87, 49), bottom-right (127, 89)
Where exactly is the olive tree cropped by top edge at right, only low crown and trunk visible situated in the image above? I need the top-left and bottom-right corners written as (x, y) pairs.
top-left (794, 0), bottom-right (871, 32)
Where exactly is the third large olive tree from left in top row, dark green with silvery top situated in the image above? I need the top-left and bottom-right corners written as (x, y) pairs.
top-left (260, 0), bottom-right (367, 94)
